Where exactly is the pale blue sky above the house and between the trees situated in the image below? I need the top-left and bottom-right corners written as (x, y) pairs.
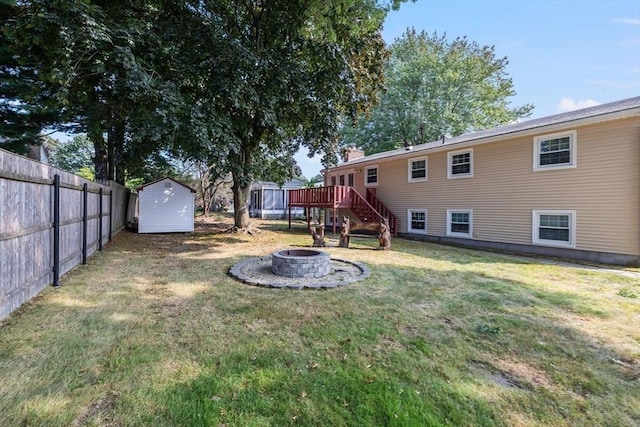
top-left (296, 0), bottom-right (640, 178)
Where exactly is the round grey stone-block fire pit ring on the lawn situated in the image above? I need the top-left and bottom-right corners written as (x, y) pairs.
top-left (271, 249), bottom-right (331, 278)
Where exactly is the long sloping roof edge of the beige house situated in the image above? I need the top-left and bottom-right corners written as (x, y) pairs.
top-left (331, 96), bottom-right (640, 169)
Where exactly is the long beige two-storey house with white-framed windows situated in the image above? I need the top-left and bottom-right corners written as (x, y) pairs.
top-left (292, 97), bottom-right (640, 264)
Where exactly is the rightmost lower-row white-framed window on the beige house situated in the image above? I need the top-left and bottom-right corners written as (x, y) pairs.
top-left (532, 210), bottom-right (576, 248)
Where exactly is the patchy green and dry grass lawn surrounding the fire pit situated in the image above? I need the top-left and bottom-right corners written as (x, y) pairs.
top-left (0, 217), bottom-right (640, 426)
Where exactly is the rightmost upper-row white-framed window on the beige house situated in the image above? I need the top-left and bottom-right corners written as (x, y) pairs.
top-left (533, 131), bottom-right (576, 170)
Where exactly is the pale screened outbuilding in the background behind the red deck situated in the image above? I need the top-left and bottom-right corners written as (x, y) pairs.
top-left (249, 180), bottom-right (304, 219)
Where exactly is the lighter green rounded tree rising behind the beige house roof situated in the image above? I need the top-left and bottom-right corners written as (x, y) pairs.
top-left (341, 30), bottom-right (533, 154)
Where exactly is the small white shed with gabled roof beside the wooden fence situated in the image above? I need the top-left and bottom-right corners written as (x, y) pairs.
top-left (138, 178), bottom-right (196, 233)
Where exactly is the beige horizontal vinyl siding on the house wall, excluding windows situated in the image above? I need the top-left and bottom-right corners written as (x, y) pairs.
top-left (338, 117), bottom-right (640, 255)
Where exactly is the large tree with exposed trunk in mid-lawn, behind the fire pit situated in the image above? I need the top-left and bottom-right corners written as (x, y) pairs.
top-left (188, 0), bottom-right (392, 228)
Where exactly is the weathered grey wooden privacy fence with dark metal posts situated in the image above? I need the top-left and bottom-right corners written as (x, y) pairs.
top-left (0, 149), bottom-right (129, 319)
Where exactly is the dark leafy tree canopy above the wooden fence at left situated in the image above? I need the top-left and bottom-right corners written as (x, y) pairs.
top-left (0, 0), bottom-right (190, 183)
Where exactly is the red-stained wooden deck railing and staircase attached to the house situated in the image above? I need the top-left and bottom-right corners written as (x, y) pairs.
top-left (289, 185), bottom-right (398, 236)
